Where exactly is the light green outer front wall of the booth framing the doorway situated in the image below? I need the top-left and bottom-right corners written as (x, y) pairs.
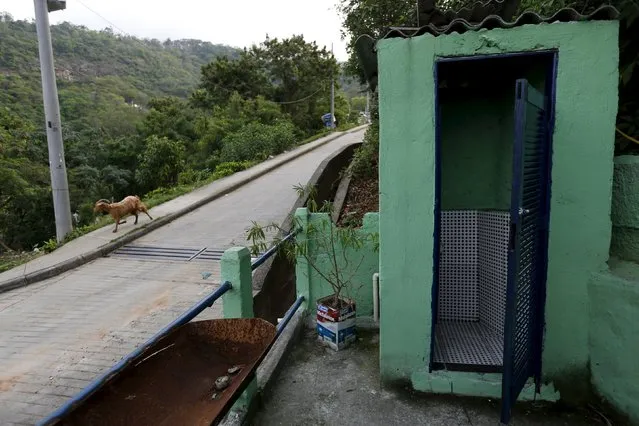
top-left (378, 22), bottom-right (618, 397)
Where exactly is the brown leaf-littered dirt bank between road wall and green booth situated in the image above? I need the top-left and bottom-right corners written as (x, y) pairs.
top-left (337, 175), bottom-right (379, 226)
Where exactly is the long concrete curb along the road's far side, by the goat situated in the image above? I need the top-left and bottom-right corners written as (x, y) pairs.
top-left (0, 125), bottom-right (366, 293)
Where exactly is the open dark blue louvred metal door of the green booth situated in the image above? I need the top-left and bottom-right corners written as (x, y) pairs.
top-left (501, 79), bottom-right (551, 424)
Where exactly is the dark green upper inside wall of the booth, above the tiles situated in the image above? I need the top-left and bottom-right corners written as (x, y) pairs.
top-left (441, 93), bottom-right (514, 210)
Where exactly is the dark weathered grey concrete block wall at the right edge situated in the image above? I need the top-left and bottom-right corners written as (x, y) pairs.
top-left (610, 155), bottom-right (639, 262)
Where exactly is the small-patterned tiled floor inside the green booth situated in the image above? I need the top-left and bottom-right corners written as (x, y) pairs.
top-left (433, 321), bottom-right (504, 368)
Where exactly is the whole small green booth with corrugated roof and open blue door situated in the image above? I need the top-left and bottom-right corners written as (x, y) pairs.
top-left (357, 2), bottom-right (619, 422)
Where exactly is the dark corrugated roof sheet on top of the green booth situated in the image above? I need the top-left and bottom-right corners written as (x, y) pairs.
top-left (382, 2), bottom-right (619, 38)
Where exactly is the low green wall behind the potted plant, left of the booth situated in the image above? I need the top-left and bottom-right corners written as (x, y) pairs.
top-left (296, 209), bottom-right (379, 317)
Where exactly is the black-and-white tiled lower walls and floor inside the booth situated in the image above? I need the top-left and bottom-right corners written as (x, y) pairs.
top-left (434, 210), bottom-right (510, 367)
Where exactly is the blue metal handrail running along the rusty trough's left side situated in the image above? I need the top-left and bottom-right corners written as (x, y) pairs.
top-left (38, 281), bottom-right (233, 426)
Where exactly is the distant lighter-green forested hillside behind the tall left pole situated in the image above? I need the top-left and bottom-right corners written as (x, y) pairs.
top-left (0, 14), bottom-right (240, 130)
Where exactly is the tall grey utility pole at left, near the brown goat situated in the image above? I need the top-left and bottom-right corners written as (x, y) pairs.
top-left (34, 0), bottom-right (73, 242)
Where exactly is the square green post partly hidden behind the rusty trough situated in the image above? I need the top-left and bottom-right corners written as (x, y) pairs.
top-left (220, 247), bottom-right (257, 411)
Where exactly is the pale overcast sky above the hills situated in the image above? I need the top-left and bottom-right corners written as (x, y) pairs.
top-left (0, 0), bottom-right (347, 61)
